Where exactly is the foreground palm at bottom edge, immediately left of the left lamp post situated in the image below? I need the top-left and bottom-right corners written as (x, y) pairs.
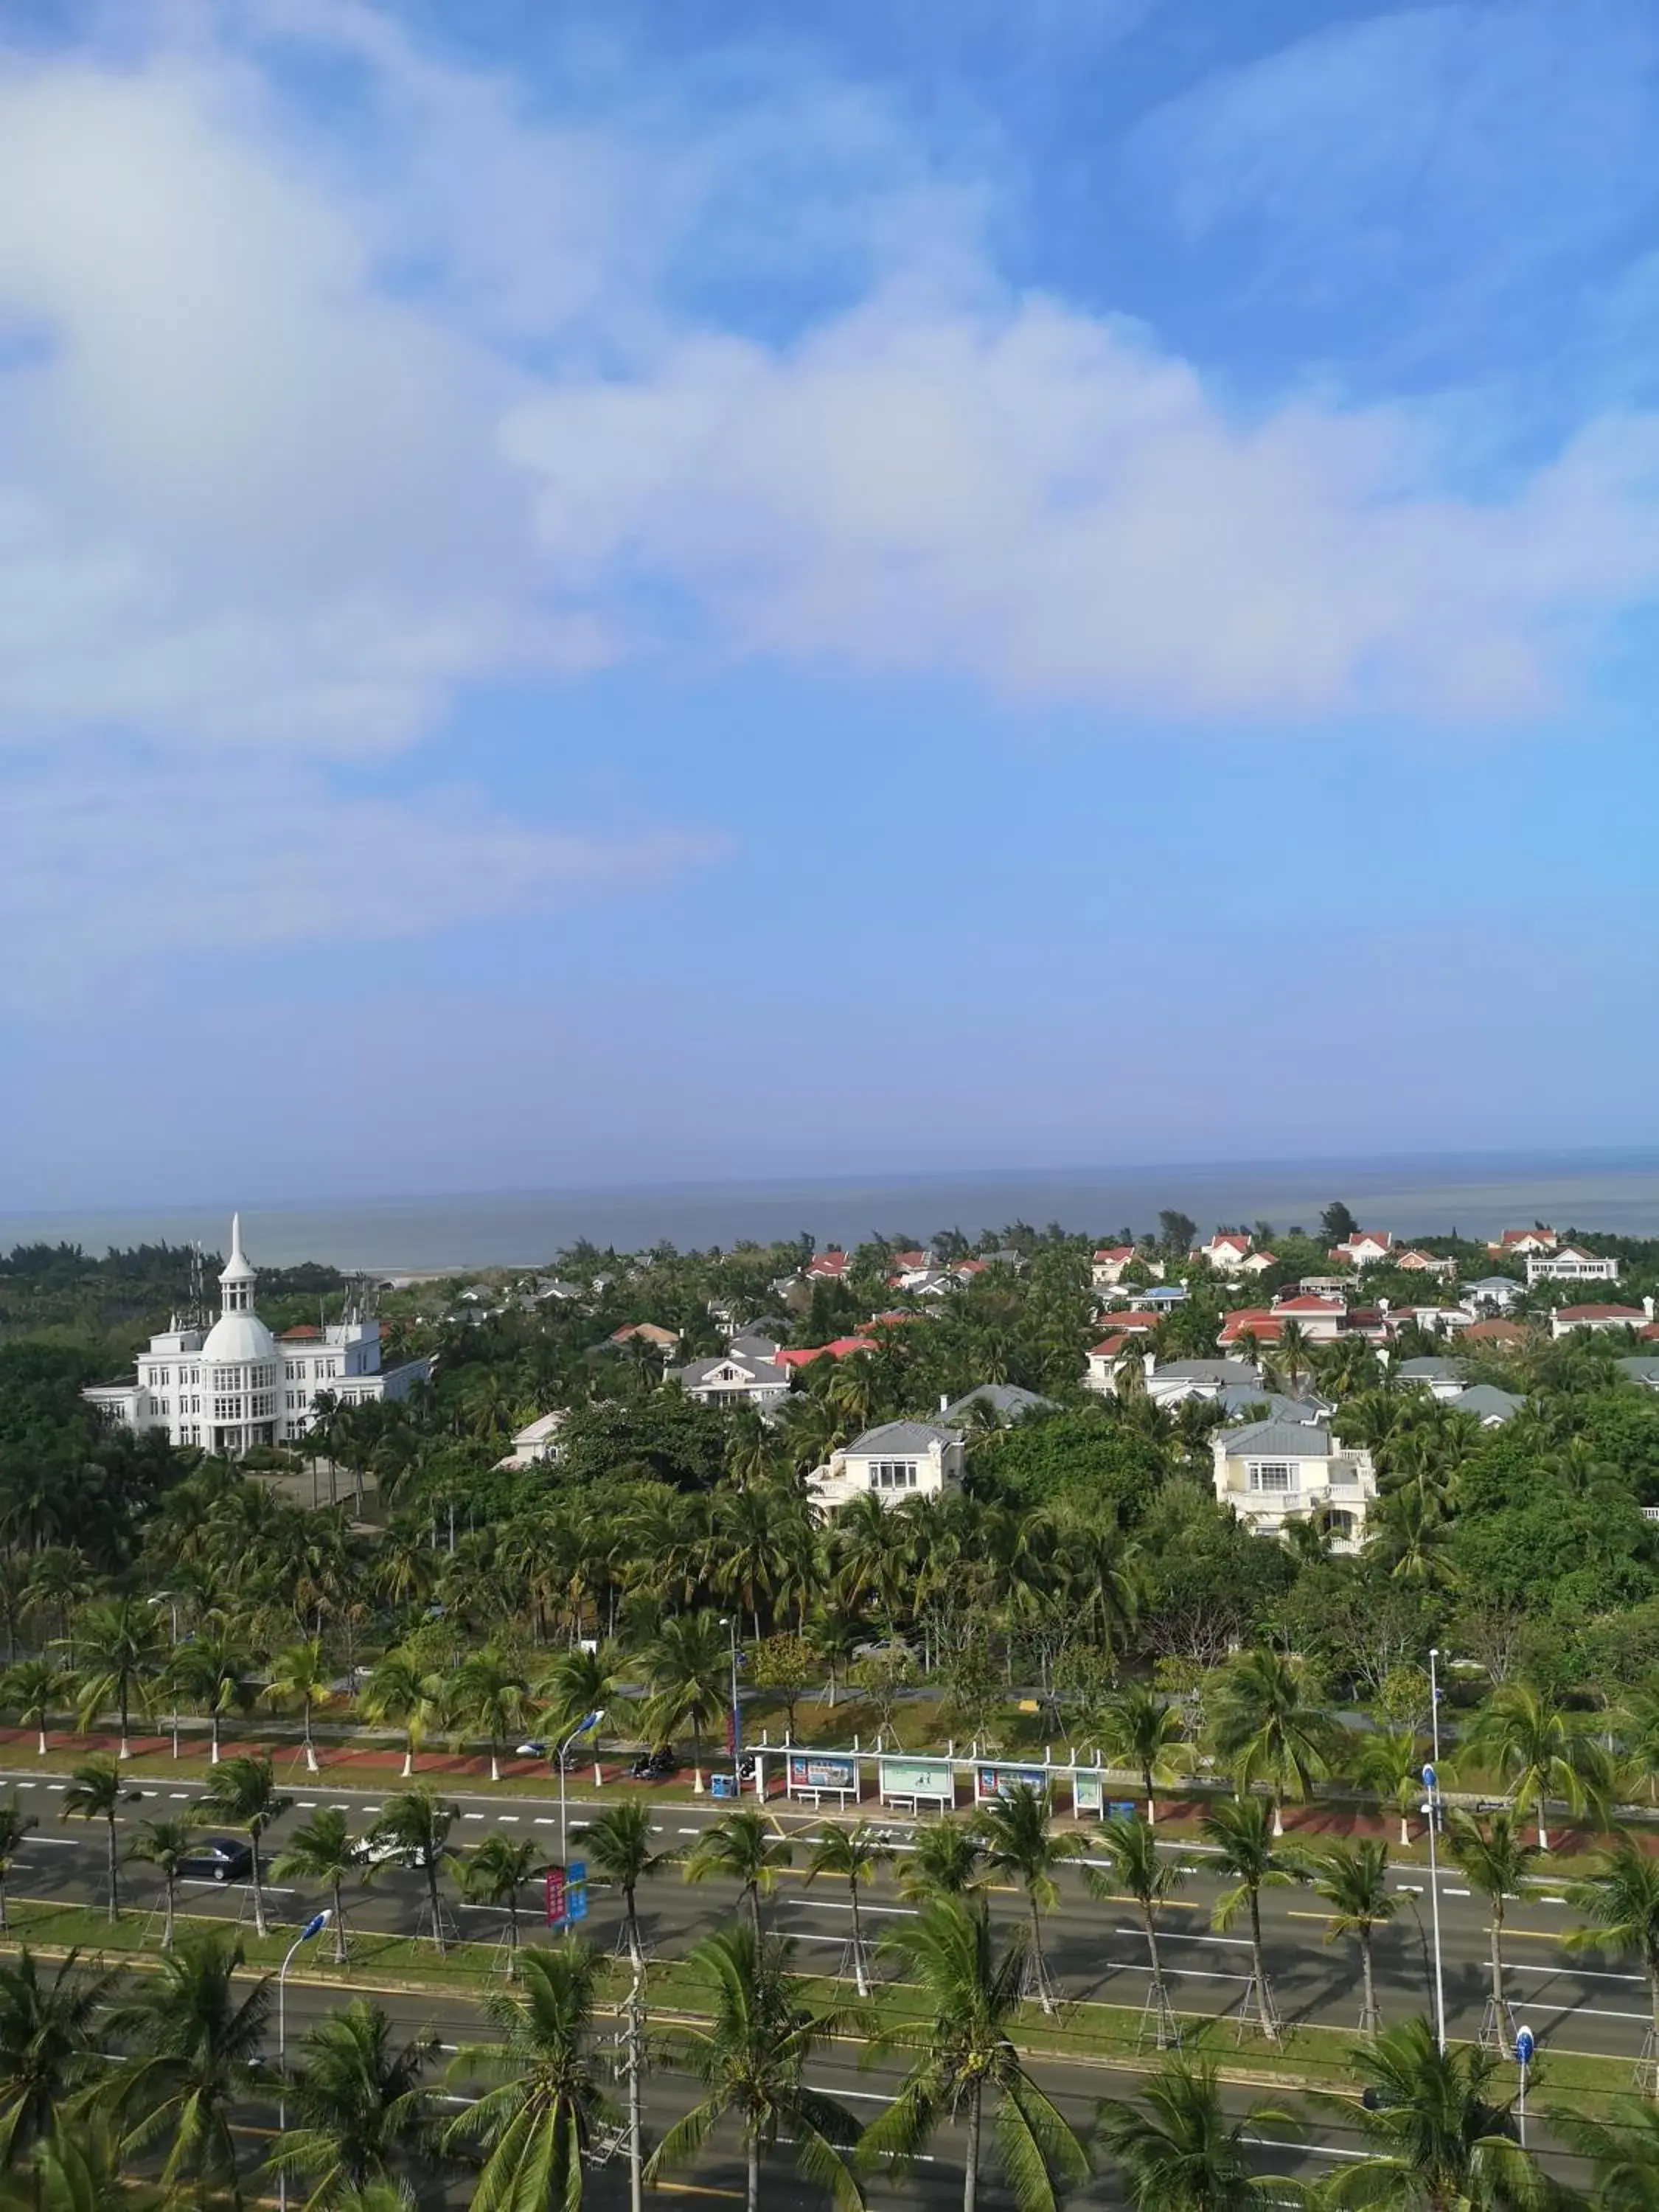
top-left (111, 1929), bottom-right (270, 2208)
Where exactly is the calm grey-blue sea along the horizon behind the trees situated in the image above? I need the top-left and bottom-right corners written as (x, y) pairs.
top-left (0, 1152), bottom-right (1659, 1272)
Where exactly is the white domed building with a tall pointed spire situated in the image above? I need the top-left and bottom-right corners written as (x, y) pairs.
top-left (84, 1214), bottom-right (431, 1460)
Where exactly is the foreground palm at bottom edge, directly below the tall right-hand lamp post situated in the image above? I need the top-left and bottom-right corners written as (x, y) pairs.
top-left (1323, 2017), bottom-right (1546, 2212)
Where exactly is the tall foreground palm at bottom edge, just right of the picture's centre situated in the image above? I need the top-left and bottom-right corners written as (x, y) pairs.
top-left (863, 1898), bottom-right (1088, 2212)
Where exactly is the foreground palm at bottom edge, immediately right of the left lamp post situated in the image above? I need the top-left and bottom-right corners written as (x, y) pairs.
top-left (268, 1997), bottom-right (438, 2212)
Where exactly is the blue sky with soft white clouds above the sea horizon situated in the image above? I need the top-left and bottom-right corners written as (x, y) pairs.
top-left (0, 0), bottom-right (1659, 1208)
